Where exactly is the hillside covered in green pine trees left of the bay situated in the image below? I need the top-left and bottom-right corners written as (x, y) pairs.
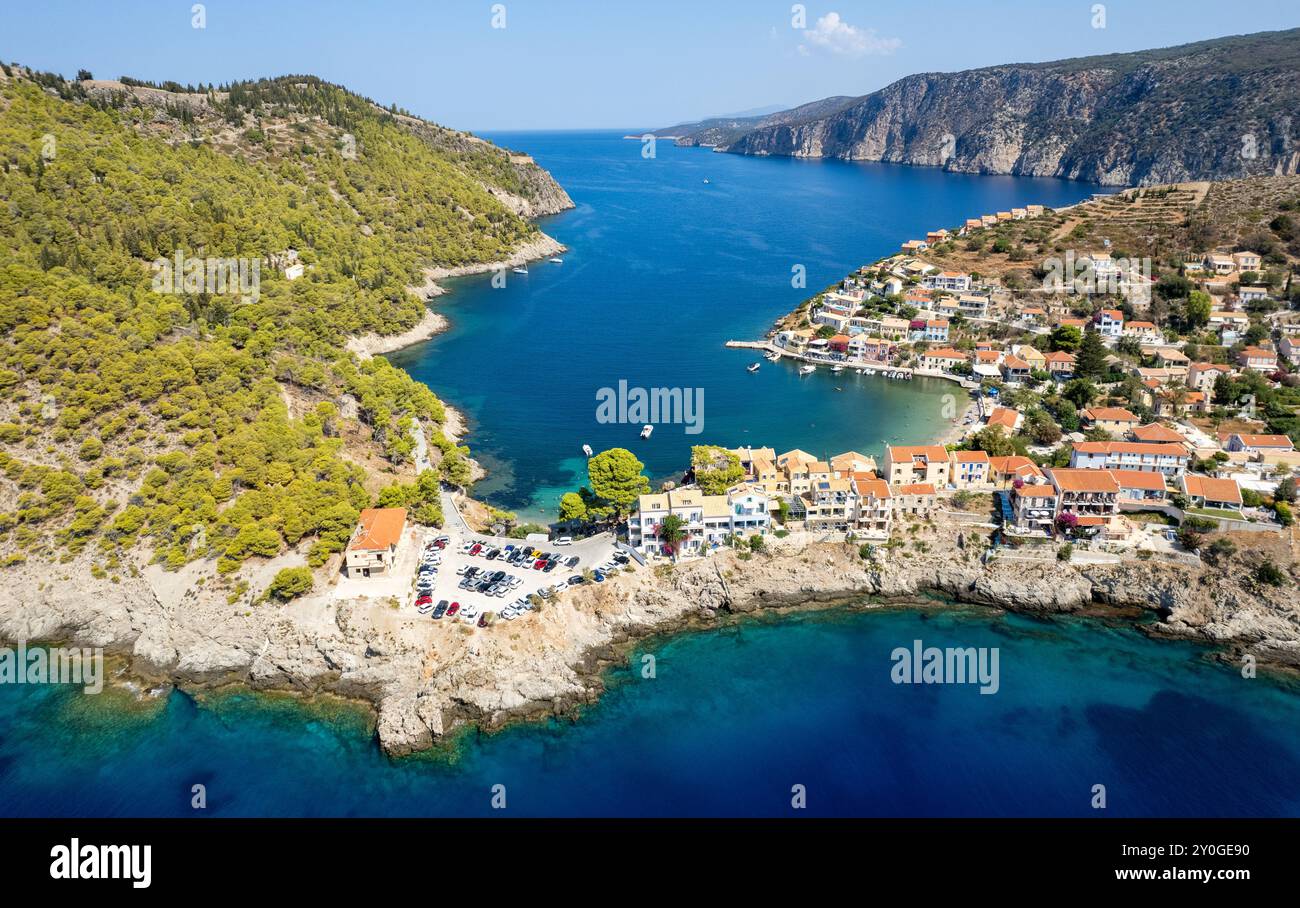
top-left (0, 66), bottom-right (553, 574)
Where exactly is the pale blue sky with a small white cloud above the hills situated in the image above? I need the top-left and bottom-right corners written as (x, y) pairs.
top-left (0, 0), bottom-right (1300, 131)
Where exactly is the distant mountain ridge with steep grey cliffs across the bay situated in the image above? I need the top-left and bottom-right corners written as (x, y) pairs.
top-left (660, 29), bottom-right (1300, 185)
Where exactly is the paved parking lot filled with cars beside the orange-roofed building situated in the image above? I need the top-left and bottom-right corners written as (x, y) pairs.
top-left (403, 529), bottom-right (634, 626)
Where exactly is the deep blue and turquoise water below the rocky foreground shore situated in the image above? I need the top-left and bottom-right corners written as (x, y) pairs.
top-left (0, 611), bottom-right (1300, 816)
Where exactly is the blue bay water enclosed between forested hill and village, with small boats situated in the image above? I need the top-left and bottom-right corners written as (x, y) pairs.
top-left (393, 133), bottom-right (1096, 519)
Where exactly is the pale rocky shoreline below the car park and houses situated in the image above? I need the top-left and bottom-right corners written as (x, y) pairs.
top-left (0, 522), bottom-right (1300, 756)
